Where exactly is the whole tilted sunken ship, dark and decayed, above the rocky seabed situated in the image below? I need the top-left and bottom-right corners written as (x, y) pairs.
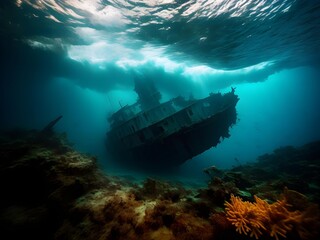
top-left (106, 81), bottom-right (239, 170)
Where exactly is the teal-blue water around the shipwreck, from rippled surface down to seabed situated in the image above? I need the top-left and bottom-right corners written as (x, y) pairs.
top-left (0, 0), bottom-right (320, 182)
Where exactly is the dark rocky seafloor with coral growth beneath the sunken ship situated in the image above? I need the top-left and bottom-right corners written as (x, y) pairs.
top-left (0, 130), bottom-right (320, 240)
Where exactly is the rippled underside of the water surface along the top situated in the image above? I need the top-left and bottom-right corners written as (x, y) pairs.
top-left (16, 0), bottom-right (320, 70)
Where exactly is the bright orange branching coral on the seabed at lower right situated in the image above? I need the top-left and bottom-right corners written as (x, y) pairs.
top-left (225, 195), bottom-right (302, 240)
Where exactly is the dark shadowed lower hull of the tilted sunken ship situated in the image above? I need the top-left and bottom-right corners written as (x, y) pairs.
top-left (107, 101), bottom-right (237, 170)
